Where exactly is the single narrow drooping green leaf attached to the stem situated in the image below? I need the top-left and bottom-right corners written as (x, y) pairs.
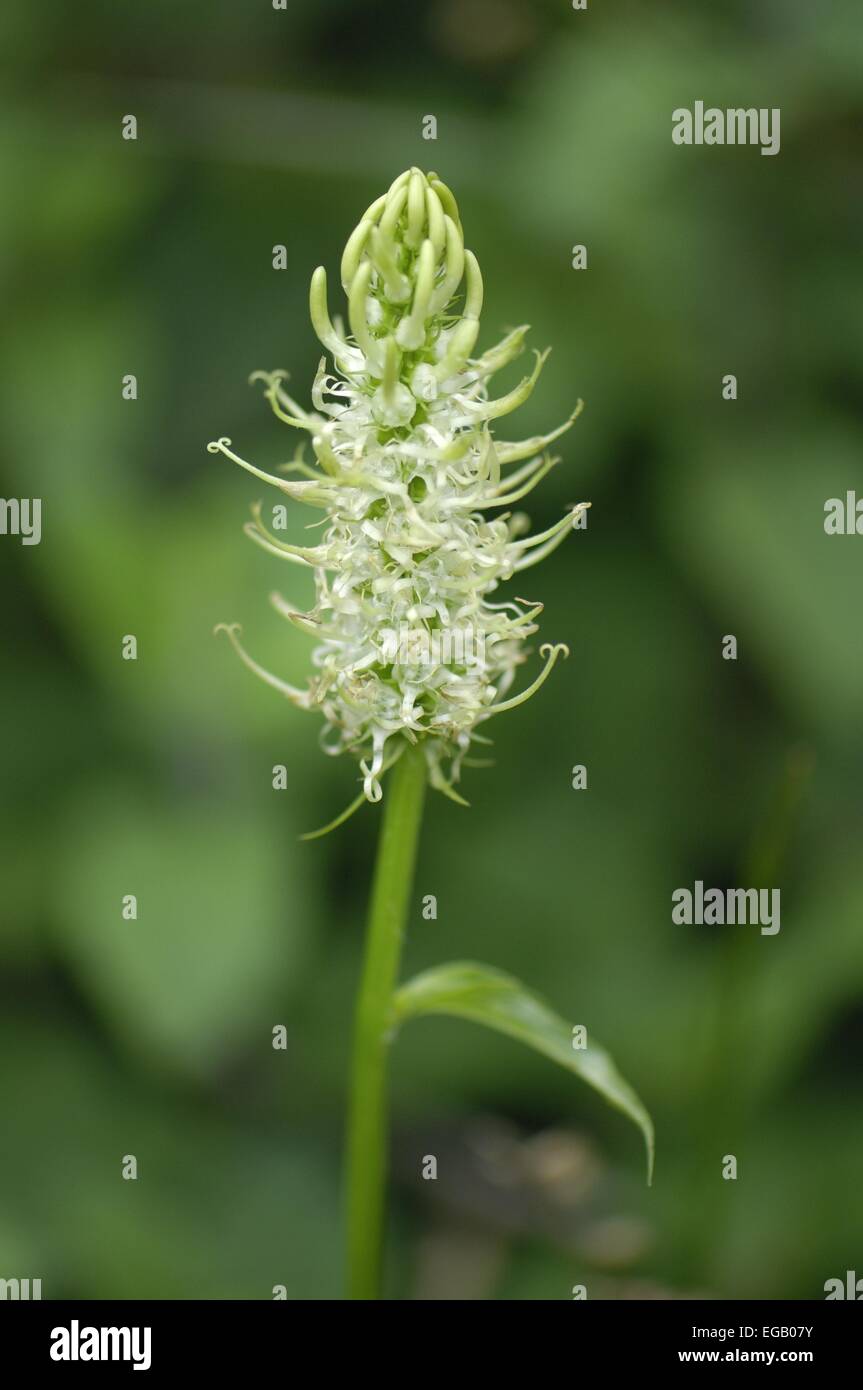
top-left (393, 960), bottom-right (653, 1184)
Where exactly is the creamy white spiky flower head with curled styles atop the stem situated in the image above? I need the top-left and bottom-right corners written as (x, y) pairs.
top-left (207, 168), bottom-right (589, 801)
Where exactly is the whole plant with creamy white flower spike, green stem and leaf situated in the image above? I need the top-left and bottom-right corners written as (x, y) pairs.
top-left (207, 168), bottom-right (653, 1298)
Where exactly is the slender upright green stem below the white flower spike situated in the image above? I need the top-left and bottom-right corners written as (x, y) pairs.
top-left (347, 745), bottom-right (427, 1298)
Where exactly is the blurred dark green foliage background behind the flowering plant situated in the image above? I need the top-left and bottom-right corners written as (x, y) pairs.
top-left (0, 0), bottom-right (863, 1300)
